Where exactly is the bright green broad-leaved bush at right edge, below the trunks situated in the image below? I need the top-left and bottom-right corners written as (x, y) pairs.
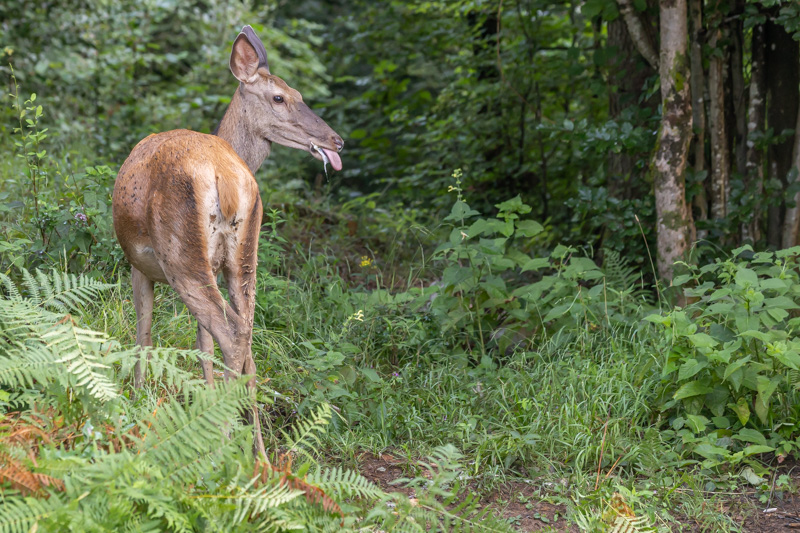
top-left (647, 246), bottom-right (800, 466)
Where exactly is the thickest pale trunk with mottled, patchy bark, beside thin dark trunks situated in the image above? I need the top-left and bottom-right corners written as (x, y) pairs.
top-left (651, 0), bottom-right (694, 282)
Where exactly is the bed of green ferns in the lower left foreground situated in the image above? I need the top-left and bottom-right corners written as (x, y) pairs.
top-left (0, 272), bottom-right (507, 533)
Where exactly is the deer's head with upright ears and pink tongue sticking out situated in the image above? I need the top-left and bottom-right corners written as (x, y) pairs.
top-left (220, 26), bottom-right (344, 170)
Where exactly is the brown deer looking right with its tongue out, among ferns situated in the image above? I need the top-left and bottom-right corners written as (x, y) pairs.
top-left (113, 26), bottom-right (344, 454)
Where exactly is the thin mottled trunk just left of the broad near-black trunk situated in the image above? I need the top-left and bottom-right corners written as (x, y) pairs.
top-left (742, 24), bottom-right (767, 244)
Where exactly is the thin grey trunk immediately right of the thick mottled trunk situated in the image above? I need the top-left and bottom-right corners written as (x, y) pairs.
top-left (689, 0), bottom-right (708, 239)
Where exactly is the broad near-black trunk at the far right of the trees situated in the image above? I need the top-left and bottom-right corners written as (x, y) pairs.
top-left (764, 18), bottom-right (800, 247)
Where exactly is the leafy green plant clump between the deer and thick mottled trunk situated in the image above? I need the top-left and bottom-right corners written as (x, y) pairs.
top-left (423, 170), bottom-right (647, 353)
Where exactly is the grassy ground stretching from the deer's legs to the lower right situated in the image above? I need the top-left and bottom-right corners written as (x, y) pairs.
top-left (75, 215), bottom-right (794, 531)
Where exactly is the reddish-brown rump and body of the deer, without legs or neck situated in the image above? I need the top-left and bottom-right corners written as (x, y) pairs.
top-left (113, 130), bottom-right (261, 291)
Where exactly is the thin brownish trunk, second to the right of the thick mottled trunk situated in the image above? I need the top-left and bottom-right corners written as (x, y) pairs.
top-left (708, 27), bottom-right (730, 220)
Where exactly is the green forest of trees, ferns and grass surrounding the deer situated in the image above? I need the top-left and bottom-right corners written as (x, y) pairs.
top-left (0, 0), bottom-right (800, 531)
